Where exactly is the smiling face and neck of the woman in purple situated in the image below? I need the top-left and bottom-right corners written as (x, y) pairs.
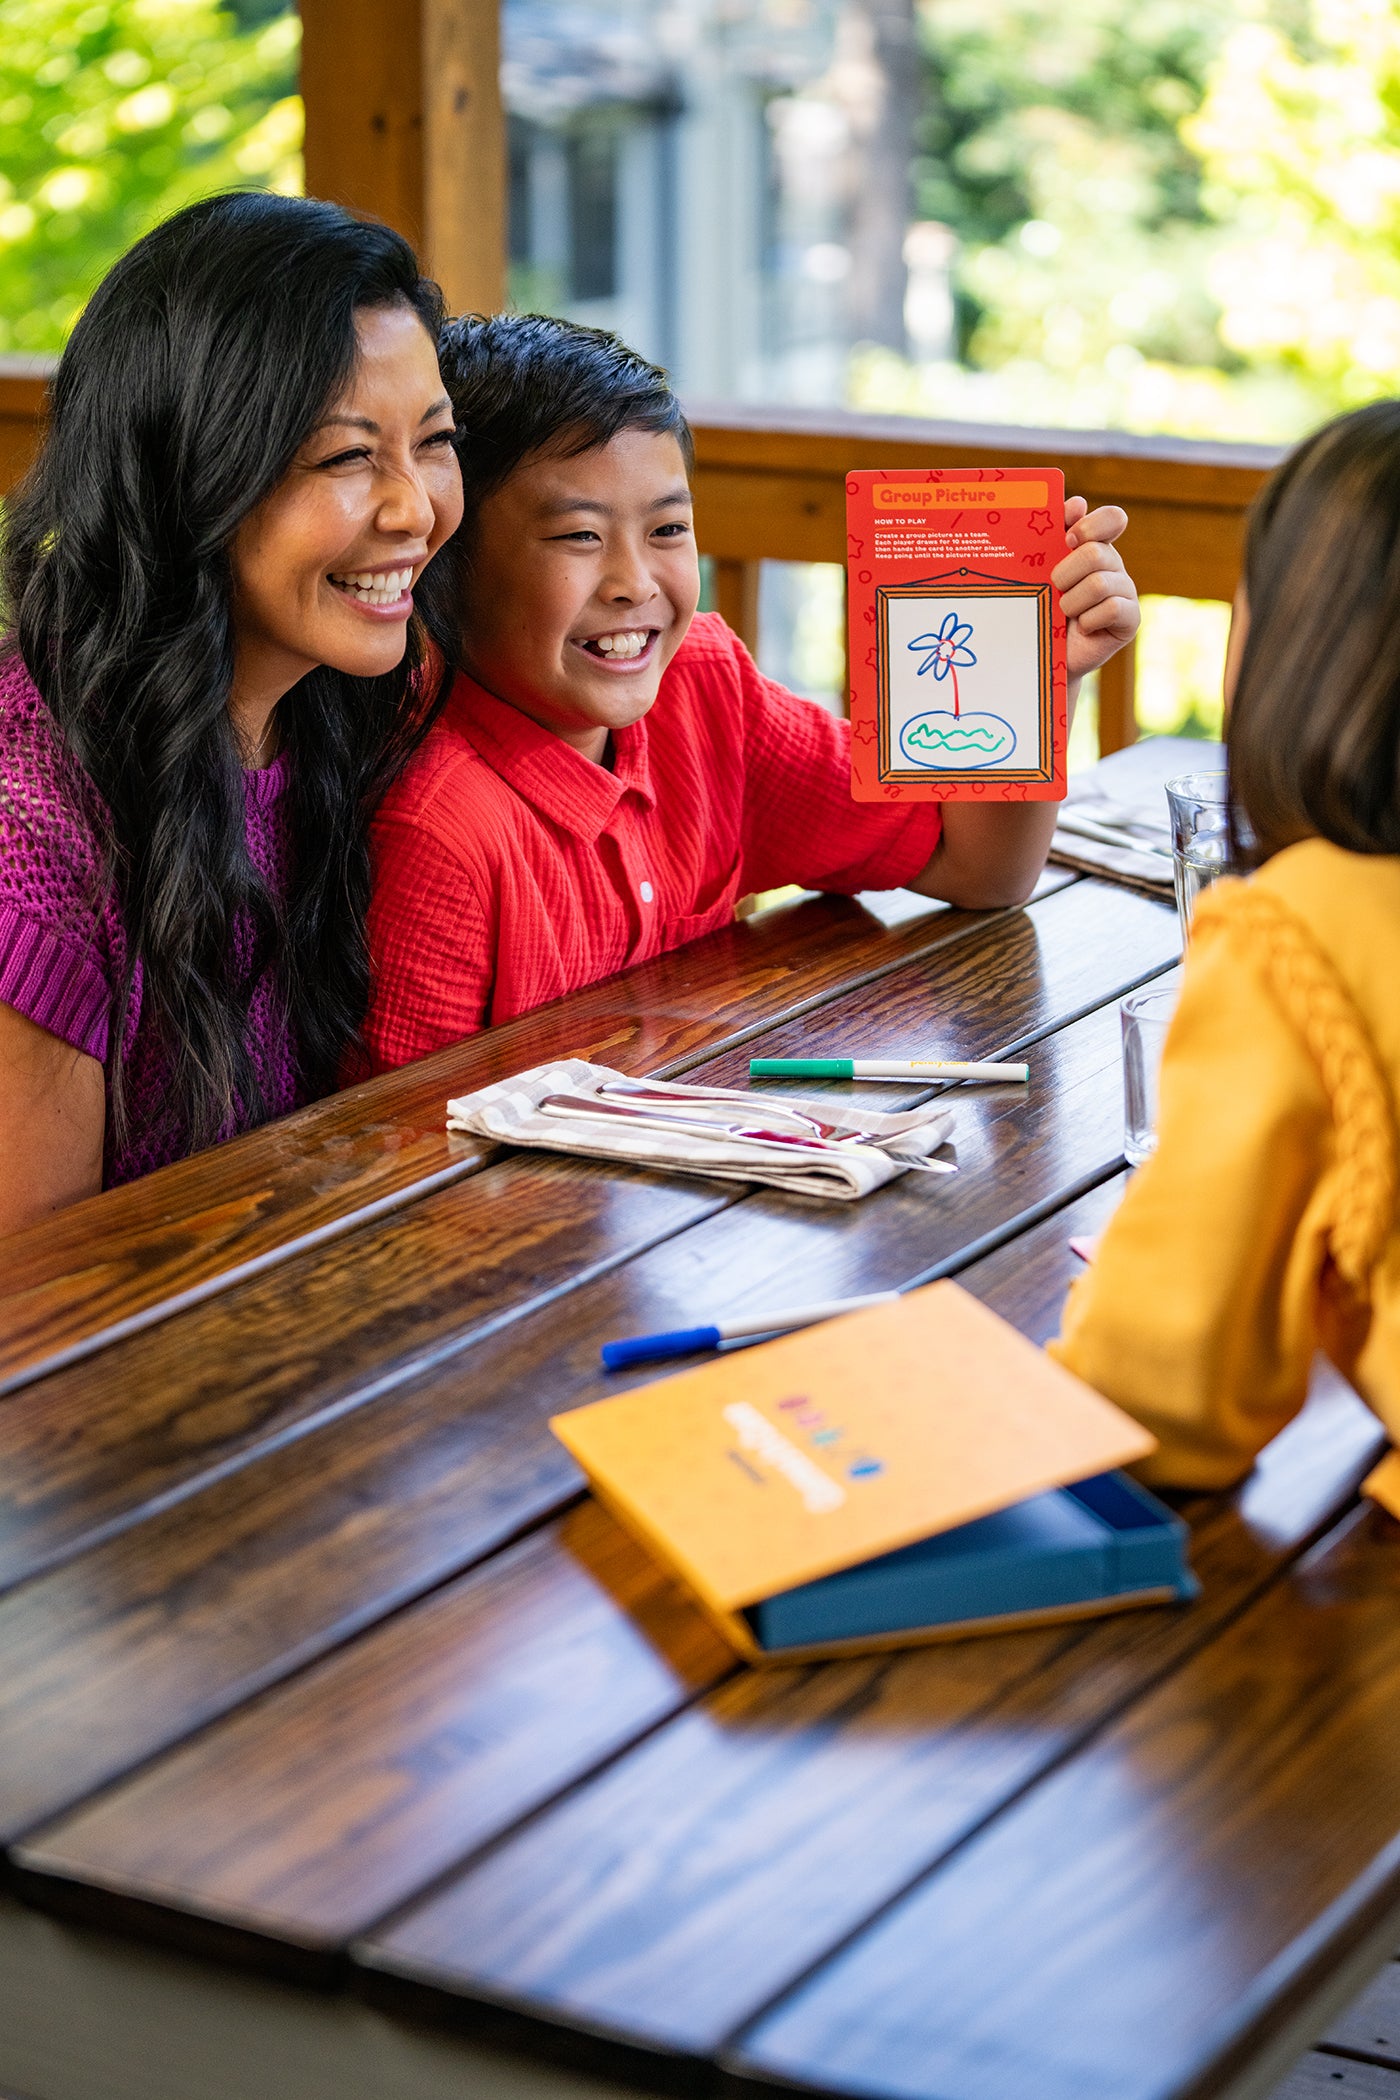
top-left (231, 305), bottom-right (462, 743)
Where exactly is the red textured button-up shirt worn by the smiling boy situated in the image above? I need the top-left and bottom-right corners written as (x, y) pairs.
top-left (365, 613), bottom-right (938, 1071)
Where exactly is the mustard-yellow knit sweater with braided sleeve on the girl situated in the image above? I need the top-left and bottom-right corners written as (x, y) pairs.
top-left (1049, 840), bottom-right (1400, 1487)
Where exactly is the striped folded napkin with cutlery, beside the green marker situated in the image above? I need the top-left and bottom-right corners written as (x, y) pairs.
top-left (447, 1058), bottom-right (953, 1203)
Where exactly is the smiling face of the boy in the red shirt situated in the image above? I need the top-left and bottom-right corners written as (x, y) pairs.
top-left (462, 431), bottom-right (699, 762)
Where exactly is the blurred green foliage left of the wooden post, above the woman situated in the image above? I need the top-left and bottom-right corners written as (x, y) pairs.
top-left (0, 0), bottom-right (302, 351)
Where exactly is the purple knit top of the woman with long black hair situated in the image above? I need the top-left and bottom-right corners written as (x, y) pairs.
top-left (0, 651), bottom-right (300, 1187)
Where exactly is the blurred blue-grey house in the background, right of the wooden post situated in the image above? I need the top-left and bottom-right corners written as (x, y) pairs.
top-left (504, 0), bottom-right (931, 403)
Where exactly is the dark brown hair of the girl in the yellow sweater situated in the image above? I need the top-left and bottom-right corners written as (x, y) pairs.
top-left (1228, 401), bottom-right (1400, 863)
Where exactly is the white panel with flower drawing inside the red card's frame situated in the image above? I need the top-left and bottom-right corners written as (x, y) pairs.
top-left (886, 592), bottom-right (1043, 773)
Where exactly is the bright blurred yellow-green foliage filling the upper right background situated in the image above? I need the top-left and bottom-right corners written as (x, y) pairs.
top-left (852, 0), bottom-right (1400, 439)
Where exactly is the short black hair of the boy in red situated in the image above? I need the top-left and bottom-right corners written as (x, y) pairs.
top-left (437, 313), bottom-right (695, 533)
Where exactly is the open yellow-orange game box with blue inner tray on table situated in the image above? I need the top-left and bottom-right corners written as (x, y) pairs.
top-left (552, 1281), bottom-right (1194, 1663)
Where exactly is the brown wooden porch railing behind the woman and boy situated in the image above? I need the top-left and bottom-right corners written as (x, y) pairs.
top-left (0, 357), bottom-right (1280, 752)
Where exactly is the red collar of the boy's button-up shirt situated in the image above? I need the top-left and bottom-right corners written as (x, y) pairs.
top-left (447, 672), bottom-right (655, 844)
